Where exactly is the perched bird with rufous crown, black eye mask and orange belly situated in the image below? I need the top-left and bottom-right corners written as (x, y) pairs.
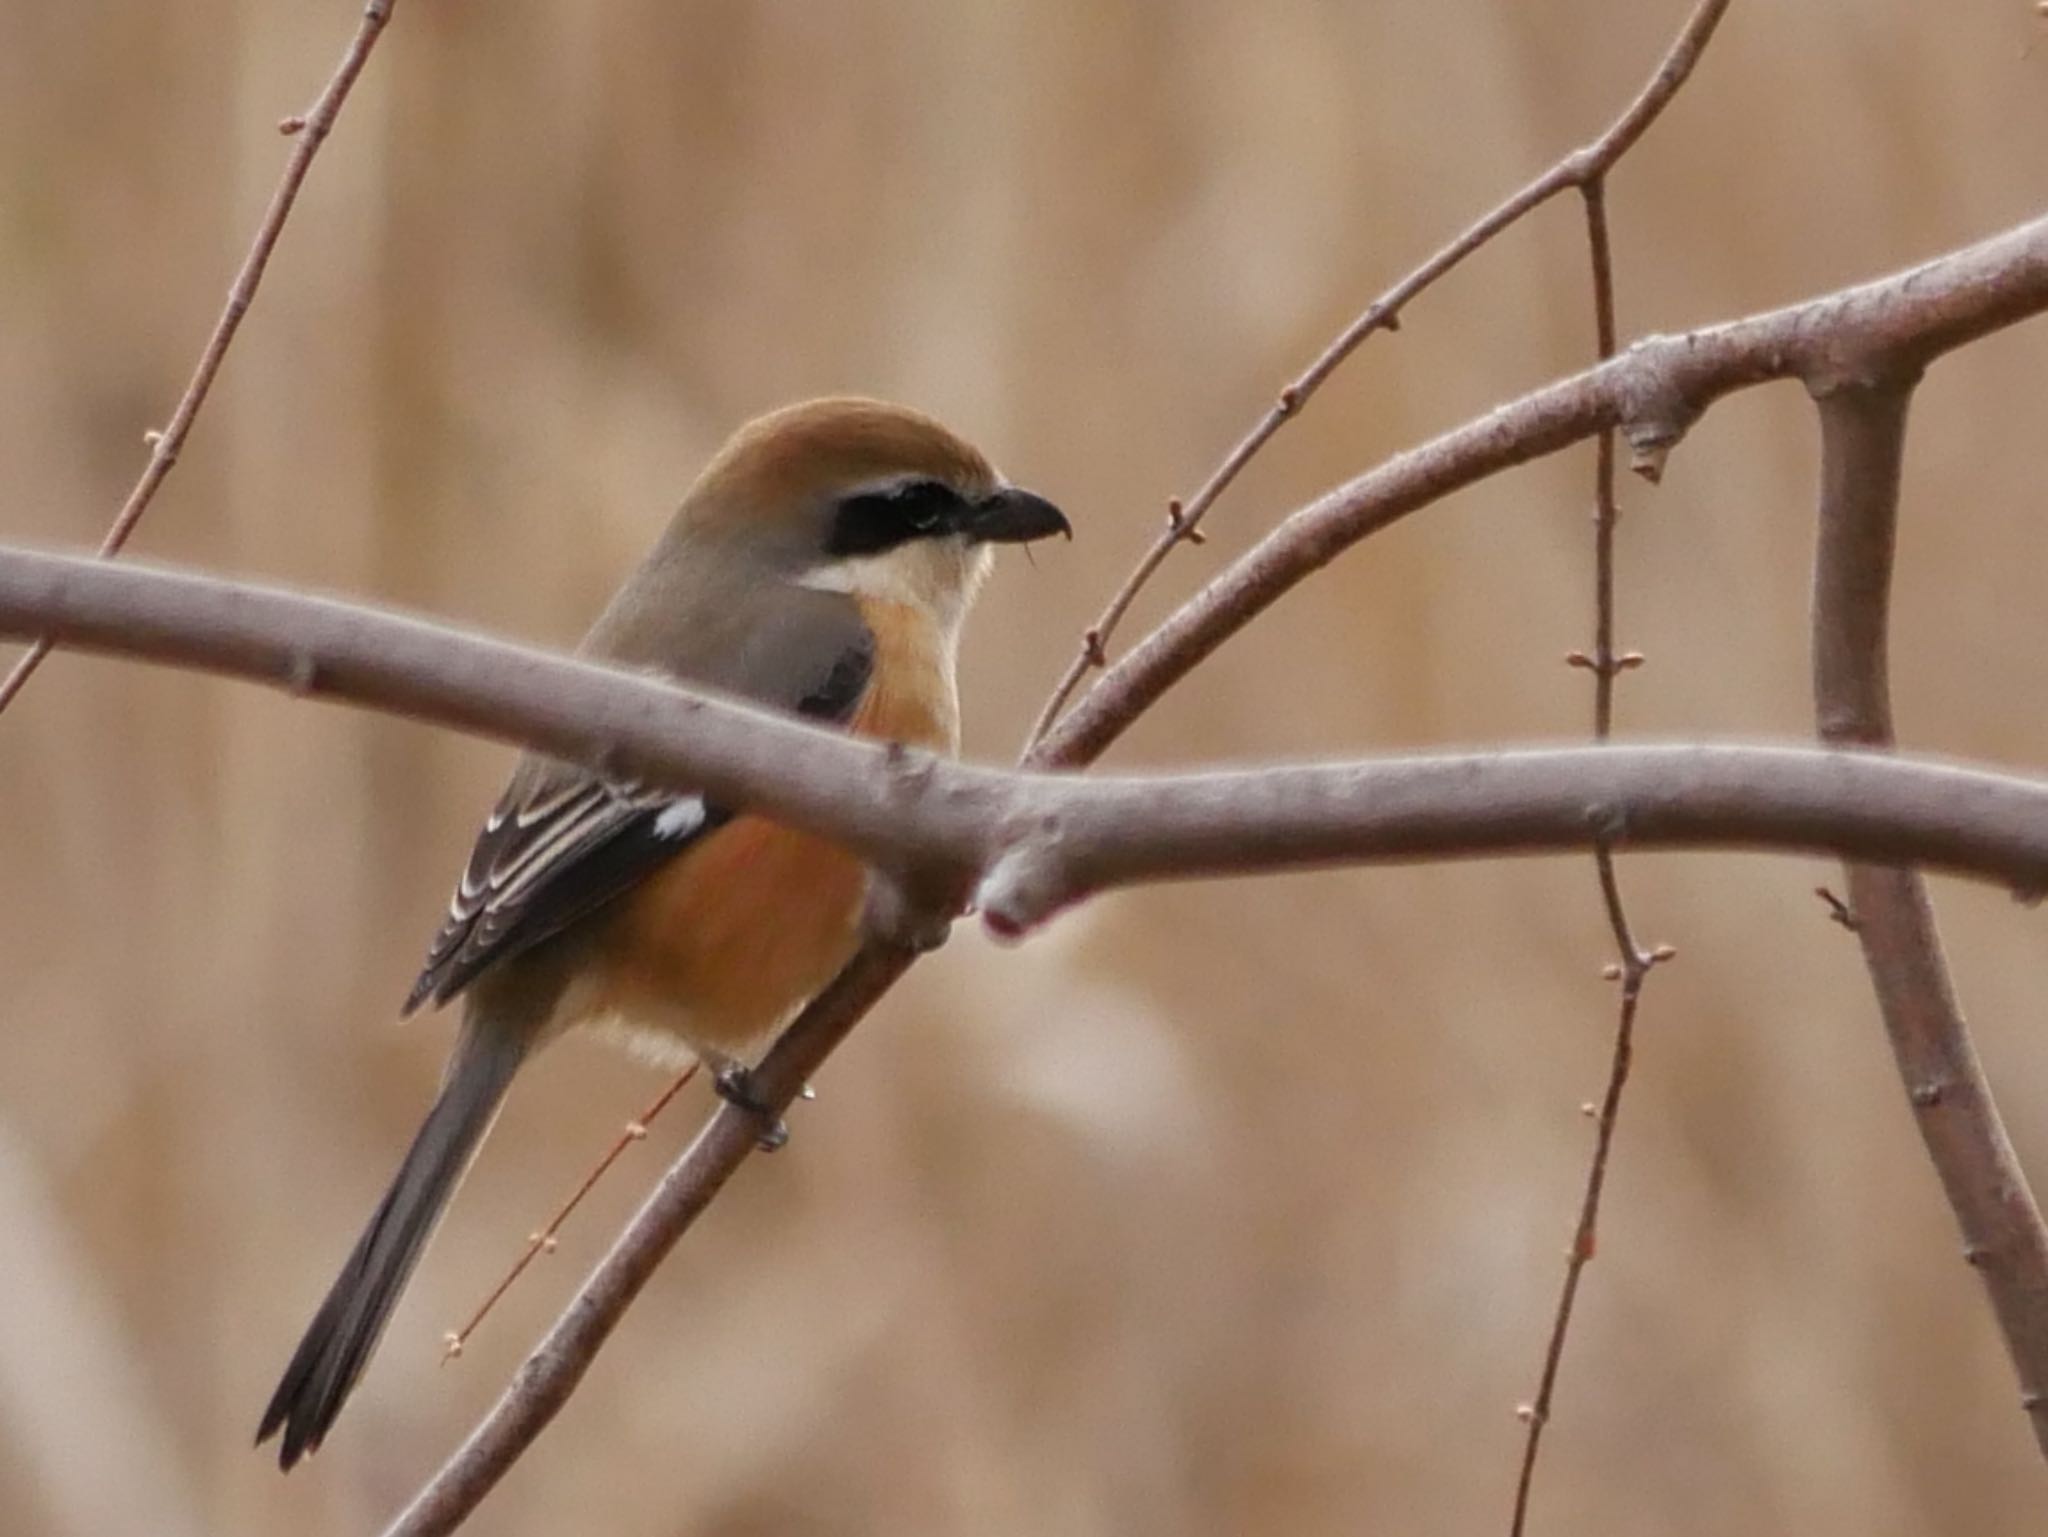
top-left (256, 398), bottom-right (1073, 1471)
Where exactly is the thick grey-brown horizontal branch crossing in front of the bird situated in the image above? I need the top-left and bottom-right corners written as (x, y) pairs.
top-left (12, 547), bottom-right (2048, 914)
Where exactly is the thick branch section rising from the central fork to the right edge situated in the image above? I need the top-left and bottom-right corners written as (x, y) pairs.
top-left (1032, 217), bottom-right (2048, 764)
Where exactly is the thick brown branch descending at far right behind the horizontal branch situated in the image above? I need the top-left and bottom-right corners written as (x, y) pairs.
top-left (1812, 373), bottom-right (2048, 1453)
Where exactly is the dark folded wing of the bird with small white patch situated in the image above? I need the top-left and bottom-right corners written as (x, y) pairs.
top-left (403, 627), bottom-right (874, 1014)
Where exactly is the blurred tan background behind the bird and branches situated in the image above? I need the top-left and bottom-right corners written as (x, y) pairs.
top-left (0, 0), bottom-right (2048, 1537)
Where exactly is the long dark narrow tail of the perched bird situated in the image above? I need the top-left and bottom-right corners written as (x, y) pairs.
top-left (256, 1019), bottom-right (526, 1471)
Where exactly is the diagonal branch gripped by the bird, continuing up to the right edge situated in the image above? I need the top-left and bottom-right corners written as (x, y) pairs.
top-left (344, 219), bottom-right (2048, 1533)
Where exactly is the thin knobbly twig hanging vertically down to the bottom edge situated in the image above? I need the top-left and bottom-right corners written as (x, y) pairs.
top-left (1507, 176), bottom-right (1671, 1537)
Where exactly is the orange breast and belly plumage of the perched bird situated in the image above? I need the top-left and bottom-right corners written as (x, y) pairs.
top-left (586, 603), bottom-right (958, 1057)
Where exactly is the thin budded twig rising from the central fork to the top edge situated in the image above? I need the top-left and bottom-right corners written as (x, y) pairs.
top-left (1024, 0), bottom-right (1729, 756)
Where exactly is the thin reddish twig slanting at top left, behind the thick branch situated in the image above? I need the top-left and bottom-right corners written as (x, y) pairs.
top-left (0, 0), bottom-right (395, 711)
